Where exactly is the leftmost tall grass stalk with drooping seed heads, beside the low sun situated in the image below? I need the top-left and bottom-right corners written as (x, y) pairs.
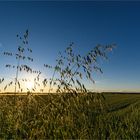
top-left (0, 29), bottom-right (41, 93)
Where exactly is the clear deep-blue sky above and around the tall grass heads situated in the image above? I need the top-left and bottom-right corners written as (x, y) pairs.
top-left (0, 1), bottom-right (140, 91)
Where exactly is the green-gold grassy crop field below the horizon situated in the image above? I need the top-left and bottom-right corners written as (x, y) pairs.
top-left (0, 93), bottom-right (140, 139)
